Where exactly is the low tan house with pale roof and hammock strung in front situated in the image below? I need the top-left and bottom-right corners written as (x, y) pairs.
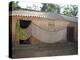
top-left (9, 10), bottom-right (78, 45)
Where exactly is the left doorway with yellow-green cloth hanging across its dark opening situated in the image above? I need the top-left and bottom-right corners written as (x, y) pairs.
top-left (17, 20), bottom-right (31, 45)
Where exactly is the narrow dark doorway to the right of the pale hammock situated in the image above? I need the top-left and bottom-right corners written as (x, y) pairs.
top-left (67, 27), bottom-right (74, 42)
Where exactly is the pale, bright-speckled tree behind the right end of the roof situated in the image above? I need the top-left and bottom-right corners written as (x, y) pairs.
top-left (63, 5), bottom-right (78, 16)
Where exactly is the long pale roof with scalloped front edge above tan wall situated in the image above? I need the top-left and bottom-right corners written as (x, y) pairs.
top-left (10, 10), bottom-right (78, 22)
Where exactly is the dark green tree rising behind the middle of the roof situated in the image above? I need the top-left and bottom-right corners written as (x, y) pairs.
top-left (41, 3), bottom-right (60, 13)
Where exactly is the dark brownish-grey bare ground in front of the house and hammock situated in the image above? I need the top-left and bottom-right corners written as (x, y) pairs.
top-left (12, 41), bottom-right (78, 58)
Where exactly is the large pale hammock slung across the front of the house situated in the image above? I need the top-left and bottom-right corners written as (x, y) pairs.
top-left (31, 23), bottom-right (66, 43)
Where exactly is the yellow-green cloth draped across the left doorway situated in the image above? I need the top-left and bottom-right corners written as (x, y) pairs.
top-left (16, 21), bottom-right (28, 40)
